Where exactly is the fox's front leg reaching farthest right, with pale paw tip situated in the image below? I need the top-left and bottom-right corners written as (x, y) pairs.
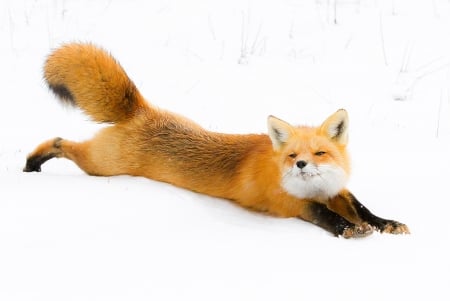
top-left (328, 190), bottom-right (409, 234)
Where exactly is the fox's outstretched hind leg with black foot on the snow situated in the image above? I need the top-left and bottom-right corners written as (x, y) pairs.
top-left (23, 137), bottom-right (91, 174)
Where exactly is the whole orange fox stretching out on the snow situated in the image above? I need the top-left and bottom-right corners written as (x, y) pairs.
top-left (23, 43), bottom-right (410, 238)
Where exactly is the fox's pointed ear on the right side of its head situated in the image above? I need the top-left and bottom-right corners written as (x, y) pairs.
top-left (319, 109), bottom-right (348, 145)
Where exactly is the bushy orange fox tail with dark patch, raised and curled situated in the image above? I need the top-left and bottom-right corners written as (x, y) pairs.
top-left (44, 43), bottom-right (145, 123)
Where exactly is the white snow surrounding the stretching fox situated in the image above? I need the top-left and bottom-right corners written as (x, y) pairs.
top-left (0, 0), bottom-right (450, 301)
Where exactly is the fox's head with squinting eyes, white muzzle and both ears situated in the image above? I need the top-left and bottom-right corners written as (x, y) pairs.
top-left (268, 110), bottom-right (350, 200)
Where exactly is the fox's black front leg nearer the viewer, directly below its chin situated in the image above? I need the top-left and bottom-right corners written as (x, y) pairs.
top-left (299, 201), bottom-right (373, 238)
